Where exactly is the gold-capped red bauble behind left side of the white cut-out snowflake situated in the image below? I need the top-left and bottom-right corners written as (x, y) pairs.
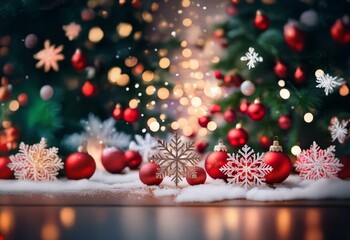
top-left (204, 140), bottom-right (227, 180)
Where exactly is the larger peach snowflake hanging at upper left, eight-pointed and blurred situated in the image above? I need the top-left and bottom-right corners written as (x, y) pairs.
top-left (34, 40), bottom-right (64, 72)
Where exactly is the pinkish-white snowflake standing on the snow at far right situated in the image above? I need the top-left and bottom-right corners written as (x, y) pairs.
top-left (294, 142), bottom-right (343, 180)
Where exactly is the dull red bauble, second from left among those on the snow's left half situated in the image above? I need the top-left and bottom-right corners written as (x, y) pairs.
top-left (101, 147), bottom-right (126, 173)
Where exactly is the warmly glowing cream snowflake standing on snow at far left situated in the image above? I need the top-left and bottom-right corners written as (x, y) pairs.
top-left (8, 138), bottom-right (63, 181)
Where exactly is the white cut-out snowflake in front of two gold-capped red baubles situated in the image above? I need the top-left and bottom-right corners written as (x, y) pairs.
top-left (220, 145), bottom-right (272, 189)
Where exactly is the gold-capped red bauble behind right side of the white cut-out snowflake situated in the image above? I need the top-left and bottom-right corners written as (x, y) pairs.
top-left (263, 137), bottom-right (293, 184)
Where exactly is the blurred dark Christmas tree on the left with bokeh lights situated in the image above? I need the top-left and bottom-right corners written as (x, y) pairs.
top-left (0, 0), bottom-right (175, 154)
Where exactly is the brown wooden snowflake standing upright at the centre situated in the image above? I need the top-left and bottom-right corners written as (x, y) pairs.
top-left (152, 133), bottom-right (200, 186)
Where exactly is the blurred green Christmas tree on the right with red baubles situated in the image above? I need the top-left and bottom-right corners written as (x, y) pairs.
top-left (209, 0), bottom-right (350, 155)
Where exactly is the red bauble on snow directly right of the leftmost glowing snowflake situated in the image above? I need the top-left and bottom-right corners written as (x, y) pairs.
top-left (64, 141), bottom-right (96, 180)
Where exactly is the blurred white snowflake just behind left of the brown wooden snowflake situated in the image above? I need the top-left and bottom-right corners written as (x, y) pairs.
top-left (129, 133), bottom-right (158, 162)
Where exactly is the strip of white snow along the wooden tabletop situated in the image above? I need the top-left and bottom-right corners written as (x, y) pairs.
top-left (0, 171), bottom-right (350, 203)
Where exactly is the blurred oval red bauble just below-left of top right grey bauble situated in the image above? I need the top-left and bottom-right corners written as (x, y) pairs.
top-left (284, 22), bottom-right (306, 52)
